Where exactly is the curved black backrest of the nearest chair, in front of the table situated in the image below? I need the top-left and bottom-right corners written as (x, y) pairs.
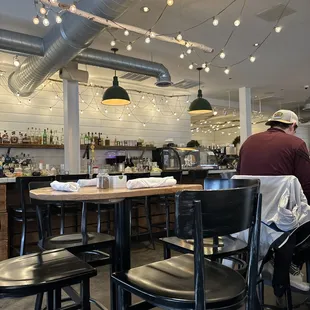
top-left (175, 179), bottom-right (260, 239)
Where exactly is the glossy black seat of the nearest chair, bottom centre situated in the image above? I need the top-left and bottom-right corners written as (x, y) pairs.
top-left (112, 254), bottom-right (247, 309)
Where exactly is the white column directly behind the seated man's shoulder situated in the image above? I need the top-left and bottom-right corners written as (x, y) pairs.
top-left (239, 87), bottom-right (252, 144)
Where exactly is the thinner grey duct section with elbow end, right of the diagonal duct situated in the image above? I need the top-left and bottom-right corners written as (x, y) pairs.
top-left (75, 48), bottom-right (172, 87)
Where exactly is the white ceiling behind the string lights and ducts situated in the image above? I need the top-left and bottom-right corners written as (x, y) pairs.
top-left (0, 0), bottom-right (310, 107)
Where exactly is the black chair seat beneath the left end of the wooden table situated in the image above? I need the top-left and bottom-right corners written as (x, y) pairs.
top-left (39, 232), bottom-right (115, 252)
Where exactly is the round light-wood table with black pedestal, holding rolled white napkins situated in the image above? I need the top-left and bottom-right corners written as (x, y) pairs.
top-left (30, 184), bottom-right (202, 308)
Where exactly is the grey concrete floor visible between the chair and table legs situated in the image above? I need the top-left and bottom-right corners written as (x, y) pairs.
top-left (0, 243), bottom-right (309, 310)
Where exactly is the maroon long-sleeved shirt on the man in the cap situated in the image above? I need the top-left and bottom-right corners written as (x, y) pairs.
top-left (237, 128), bottom-right (310, 202)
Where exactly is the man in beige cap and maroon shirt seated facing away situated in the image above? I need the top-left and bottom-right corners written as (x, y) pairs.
top-left (237, 110), bottom-right (310, 291)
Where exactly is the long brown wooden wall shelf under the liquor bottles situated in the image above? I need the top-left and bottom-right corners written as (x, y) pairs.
top-left (0, 143), bottom-right (156, 151)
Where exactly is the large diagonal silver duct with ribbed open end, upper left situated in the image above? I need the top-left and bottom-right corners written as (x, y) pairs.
top-left (8, 0), bottom-right (136, 96)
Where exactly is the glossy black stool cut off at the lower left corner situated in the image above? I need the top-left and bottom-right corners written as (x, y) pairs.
top-left (0, 249), bottom-right (97, 309)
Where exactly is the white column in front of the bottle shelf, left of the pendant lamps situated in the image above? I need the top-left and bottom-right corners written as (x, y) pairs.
top-left (63, 80), bottom-right (81, 174)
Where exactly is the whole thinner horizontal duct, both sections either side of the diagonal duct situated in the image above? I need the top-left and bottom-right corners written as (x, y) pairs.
top-left (0, 29), bottom-right (172, 91)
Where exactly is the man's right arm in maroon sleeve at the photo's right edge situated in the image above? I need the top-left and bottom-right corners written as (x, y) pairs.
top-left (294, 142), bottom-right (310, 203)
